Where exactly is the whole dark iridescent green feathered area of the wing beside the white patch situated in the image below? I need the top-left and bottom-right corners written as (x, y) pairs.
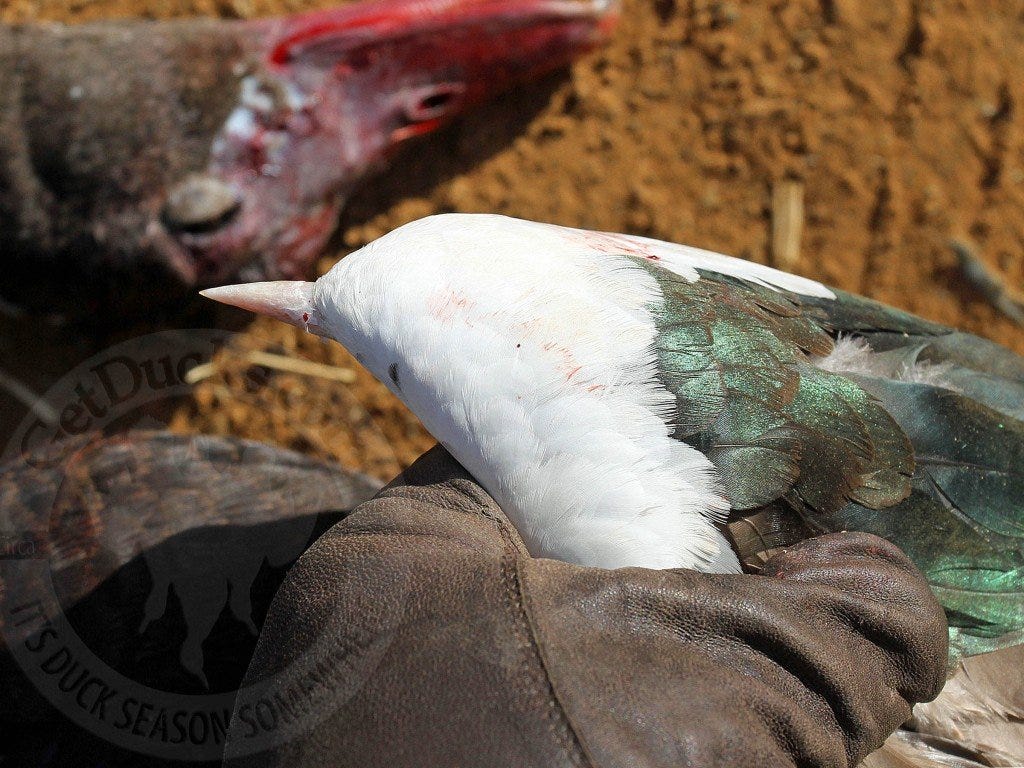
top-left (638, 260), bottom-right (1024, 656)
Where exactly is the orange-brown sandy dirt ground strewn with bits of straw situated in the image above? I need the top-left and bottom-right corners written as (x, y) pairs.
top-left (0, 0), bottom-right (1024, 478)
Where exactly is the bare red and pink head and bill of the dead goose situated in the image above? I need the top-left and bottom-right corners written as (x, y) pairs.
top-left (162, 0), bottom-right (616, 285)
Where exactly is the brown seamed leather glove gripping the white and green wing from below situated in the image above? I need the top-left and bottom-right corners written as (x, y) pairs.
top-left (227, 449), bottom-right (946, 768)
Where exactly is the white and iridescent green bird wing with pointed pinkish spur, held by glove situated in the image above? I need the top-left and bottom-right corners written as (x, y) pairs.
top-left (204, 214), bottom-right (1024, 765)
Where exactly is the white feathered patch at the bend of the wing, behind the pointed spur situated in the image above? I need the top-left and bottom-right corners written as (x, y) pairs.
top-left (313, 215), bottom-right (739, 571)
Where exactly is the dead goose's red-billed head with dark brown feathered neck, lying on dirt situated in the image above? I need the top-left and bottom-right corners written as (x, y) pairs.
top-left (0, 0), bottom-right (616, 316)
